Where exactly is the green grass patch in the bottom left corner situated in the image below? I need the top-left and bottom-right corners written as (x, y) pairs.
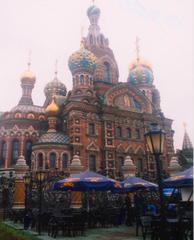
top-left (0, 223), bottom-right (40, 240)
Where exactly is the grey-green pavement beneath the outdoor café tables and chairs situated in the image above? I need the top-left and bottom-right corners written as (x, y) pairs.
top-left (6, 221), bottom-right (143, 240)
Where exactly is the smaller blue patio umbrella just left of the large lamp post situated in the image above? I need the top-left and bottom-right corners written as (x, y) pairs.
top-left (121, 177), bottom-right (158, 192)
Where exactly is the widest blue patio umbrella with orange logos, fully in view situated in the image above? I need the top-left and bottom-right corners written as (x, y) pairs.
top-left (53, 171), bottom-right (122, 192)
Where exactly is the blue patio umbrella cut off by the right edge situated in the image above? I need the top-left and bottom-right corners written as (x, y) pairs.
top-left (163, 167), bottom-right (193, 188)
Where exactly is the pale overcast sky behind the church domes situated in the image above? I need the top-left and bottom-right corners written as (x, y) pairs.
top-left (0, 0), bottom-right (194, 148)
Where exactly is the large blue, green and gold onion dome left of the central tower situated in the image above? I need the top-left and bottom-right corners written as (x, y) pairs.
top-left (68, 44), bottom-right (96, 74)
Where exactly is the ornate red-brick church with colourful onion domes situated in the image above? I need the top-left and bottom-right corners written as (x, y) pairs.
top-left (0, 5), bottom-right (174, 178)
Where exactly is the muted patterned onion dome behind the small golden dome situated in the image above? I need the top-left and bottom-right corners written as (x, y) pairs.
top-left (44, 77), bottom-right (67, 96)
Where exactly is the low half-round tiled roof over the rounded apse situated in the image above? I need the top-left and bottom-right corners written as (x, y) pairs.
top-left (37, 132), bottom-right (70, 144)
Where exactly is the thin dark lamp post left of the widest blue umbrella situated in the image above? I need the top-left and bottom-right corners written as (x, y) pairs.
top-left (36, 170), bottom-right (45, 235)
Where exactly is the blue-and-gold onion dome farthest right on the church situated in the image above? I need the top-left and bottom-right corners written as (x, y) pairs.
top-left (128, 59), bottom-right (154, 85)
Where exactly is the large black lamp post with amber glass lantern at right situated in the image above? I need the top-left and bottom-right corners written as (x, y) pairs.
top-left (144, 123), bottom-right (165, 221)
